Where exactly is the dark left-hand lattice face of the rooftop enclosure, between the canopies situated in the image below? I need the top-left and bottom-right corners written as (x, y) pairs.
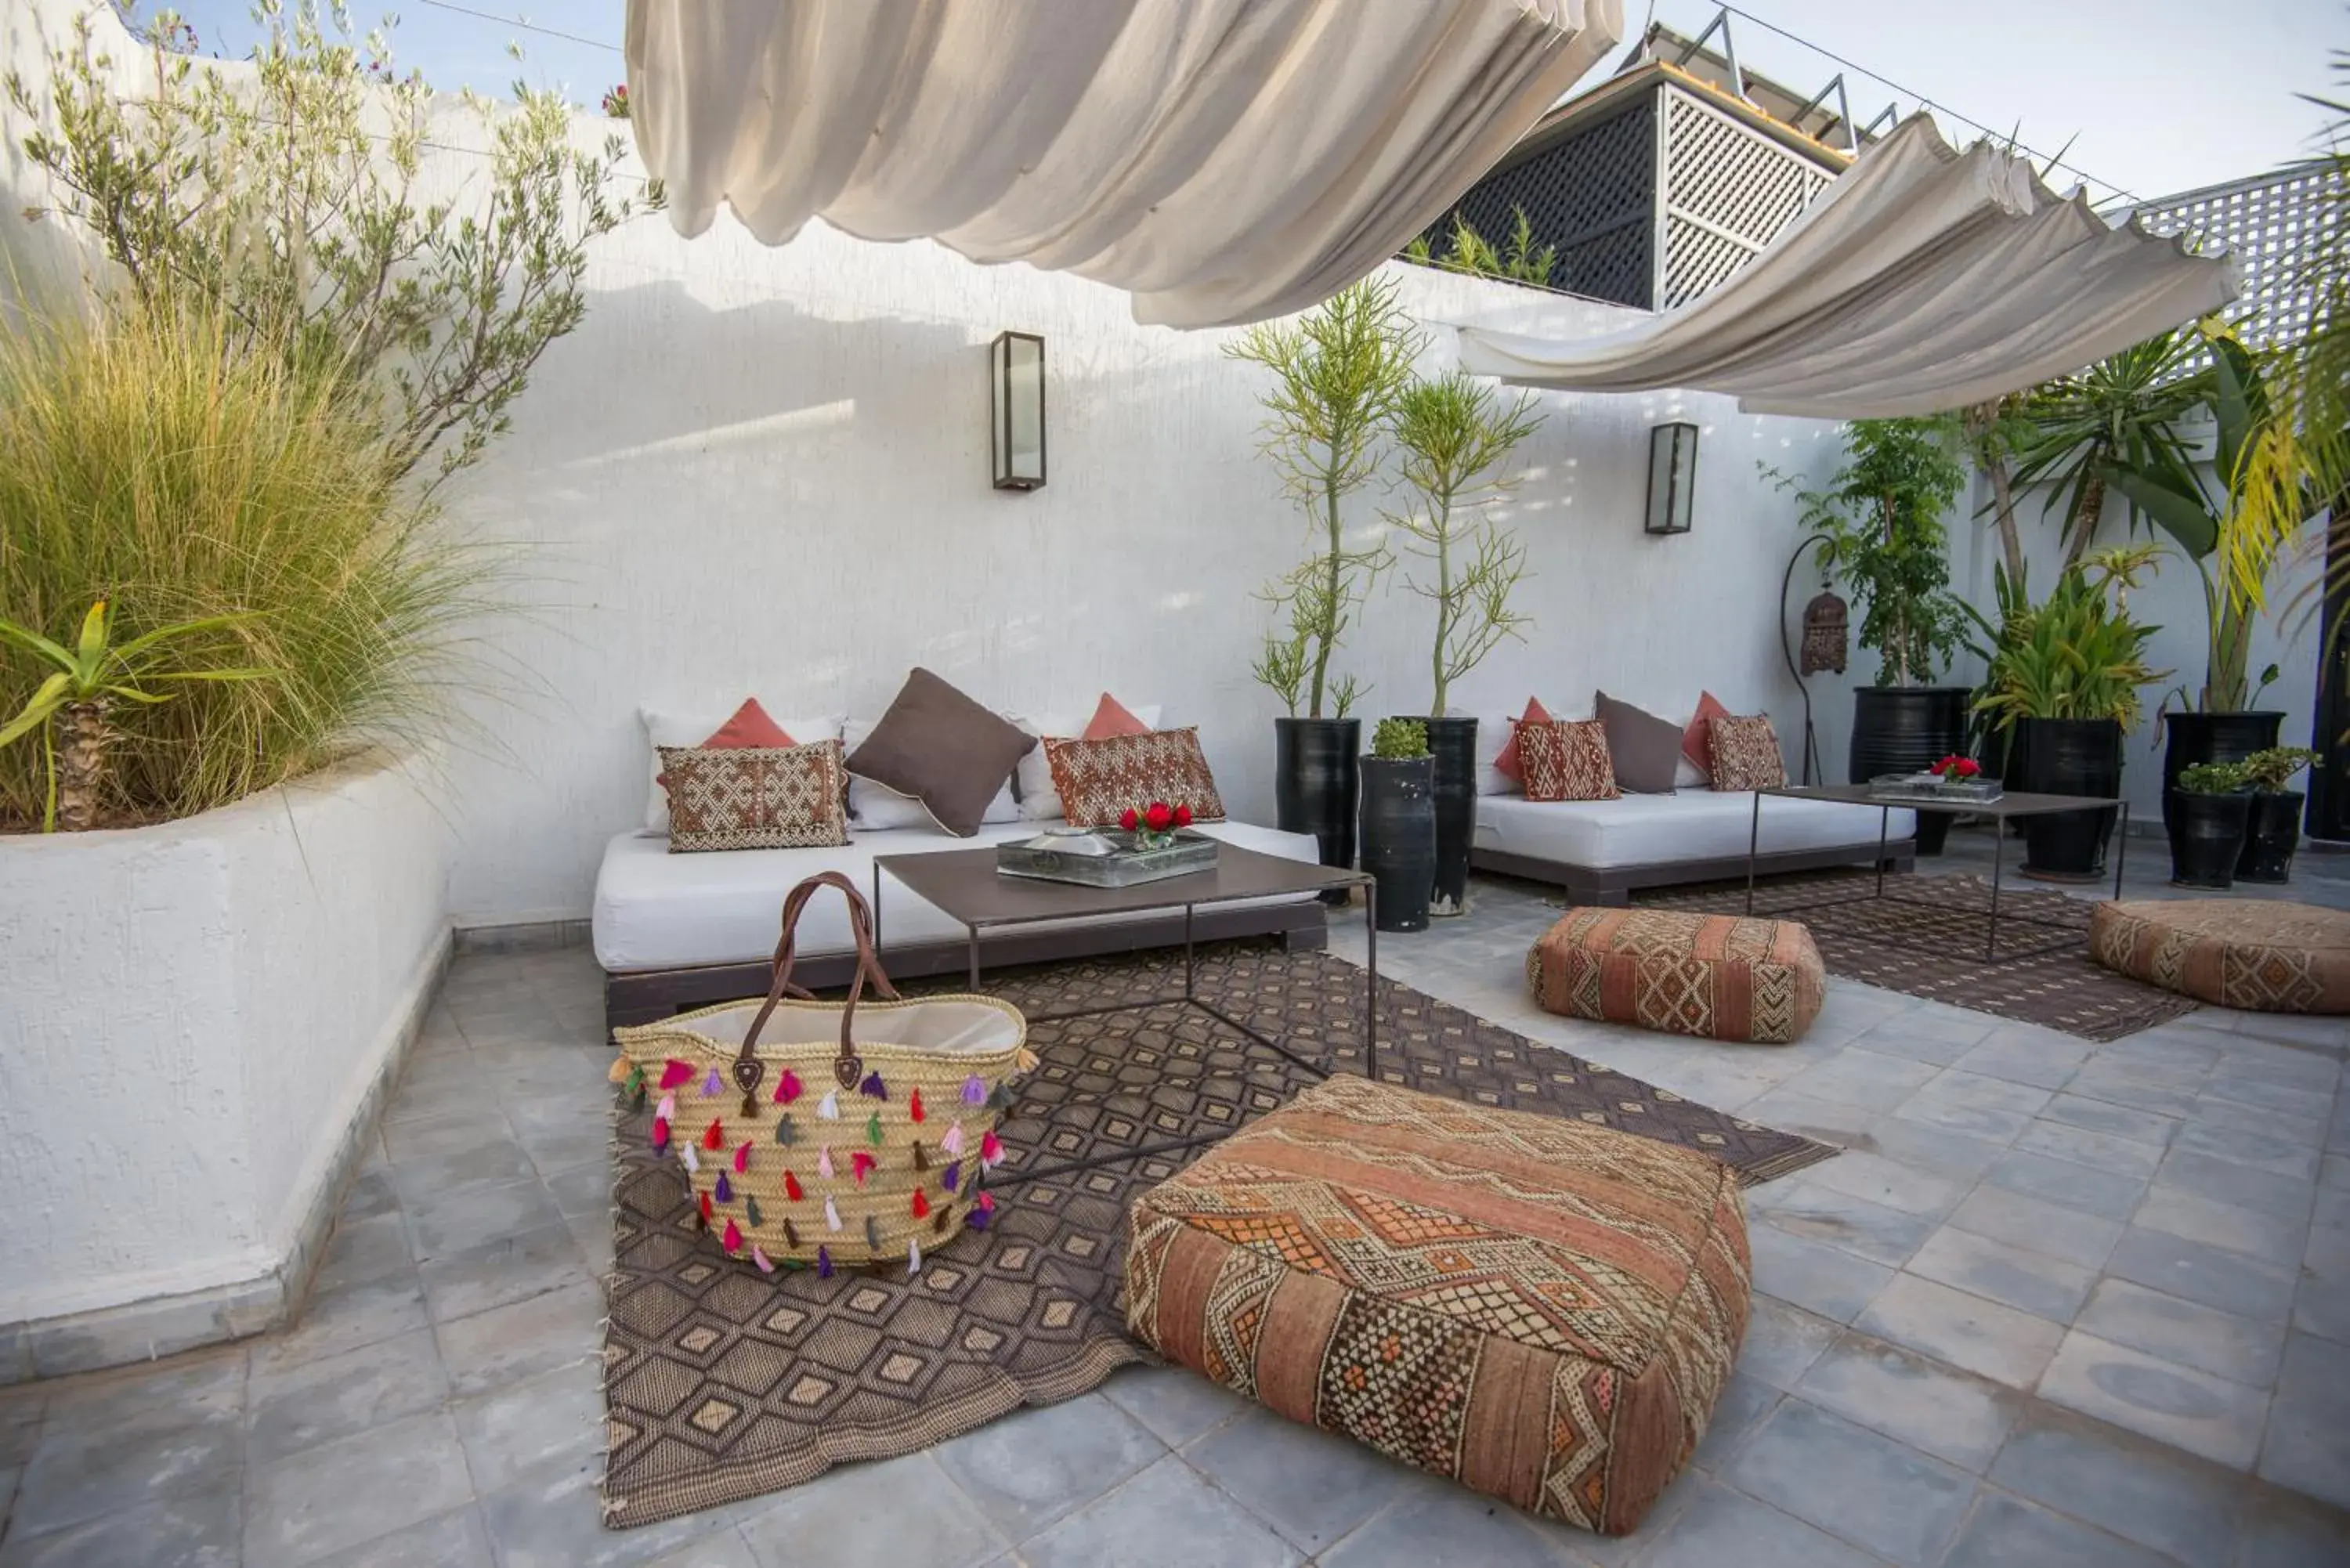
top-left (1429, 94), bottom-right (1657, 310)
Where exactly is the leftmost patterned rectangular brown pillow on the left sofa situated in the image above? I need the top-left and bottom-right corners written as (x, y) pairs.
top-left (660, 740), bottom-right (848, 856)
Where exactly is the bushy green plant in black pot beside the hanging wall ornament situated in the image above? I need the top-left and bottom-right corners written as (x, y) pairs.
top-left (1779, 416), bottom-right (1972, 856)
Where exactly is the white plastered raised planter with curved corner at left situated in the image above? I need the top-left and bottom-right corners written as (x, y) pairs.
top-left (0, 757), bottom-right (449, 1382)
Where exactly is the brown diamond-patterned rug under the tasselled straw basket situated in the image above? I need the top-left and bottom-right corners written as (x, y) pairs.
top-left (604, 943), bottom-right (1835, 1528)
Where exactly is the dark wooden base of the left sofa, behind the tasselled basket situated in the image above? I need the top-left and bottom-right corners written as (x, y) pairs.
top-left (604, 901), bottom-right (1330, 1030)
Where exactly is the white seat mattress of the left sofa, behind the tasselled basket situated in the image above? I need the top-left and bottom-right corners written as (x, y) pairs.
top-left (595, 823), bottom-right (1318, 974)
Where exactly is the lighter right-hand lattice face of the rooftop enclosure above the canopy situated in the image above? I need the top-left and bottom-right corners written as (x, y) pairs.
top-left (1657, 87), bottom-right (1831, 308)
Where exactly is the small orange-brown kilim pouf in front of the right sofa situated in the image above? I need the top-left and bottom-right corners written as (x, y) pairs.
top-left (1525, 910), bottom-right (1828, 1046)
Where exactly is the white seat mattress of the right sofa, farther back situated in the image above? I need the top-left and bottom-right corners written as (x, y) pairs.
top-left (1473, 790), bottom-right (1918, 870)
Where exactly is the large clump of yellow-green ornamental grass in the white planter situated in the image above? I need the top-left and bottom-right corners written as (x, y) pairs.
top-left (0, 303), bottom-right (496, 826)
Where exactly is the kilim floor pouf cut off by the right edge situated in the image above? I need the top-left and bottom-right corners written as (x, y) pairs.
top-left (2089, 898), bottom-right (2350, 1013)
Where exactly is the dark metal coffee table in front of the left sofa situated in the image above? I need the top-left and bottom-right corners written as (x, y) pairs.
top-left (872, 844), bottom-right (1379, 1185)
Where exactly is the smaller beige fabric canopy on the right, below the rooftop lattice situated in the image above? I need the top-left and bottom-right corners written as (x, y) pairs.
top-left (1459, 115), bottom-right (2237, 418)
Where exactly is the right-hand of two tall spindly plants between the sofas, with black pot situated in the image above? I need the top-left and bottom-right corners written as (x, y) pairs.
top-left (1386, 371), bottom-right (1542, 915)
